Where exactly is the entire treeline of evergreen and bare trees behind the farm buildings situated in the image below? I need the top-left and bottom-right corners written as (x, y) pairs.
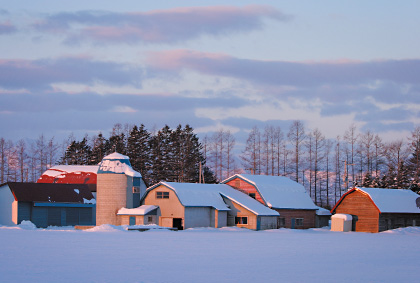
top-left (0, 121), bottom-right (420, 207)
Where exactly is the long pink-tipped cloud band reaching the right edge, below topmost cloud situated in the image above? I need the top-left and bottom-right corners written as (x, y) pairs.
top-left (149, 50), bottom-right (420, 87)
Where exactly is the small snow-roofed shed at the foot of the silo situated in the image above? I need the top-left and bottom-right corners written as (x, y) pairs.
top-left (117, 205), bottom-right (159, 225)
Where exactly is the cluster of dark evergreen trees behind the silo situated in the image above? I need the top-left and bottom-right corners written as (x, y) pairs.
top-left (60, 124), bottom-right (216, 185)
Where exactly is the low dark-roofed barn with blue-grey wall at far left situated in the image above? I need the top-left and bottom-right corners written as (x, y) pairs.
top-left (0, 182), bottom-right (96, 227)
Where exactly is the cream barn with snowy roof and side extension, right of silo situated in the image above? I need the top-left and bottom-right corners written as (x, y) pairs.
top-left (142, 182), bottom-right (279, 230)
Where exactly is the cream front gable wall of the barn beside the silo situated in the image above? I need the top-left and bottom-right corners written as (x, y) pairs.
top-left (143, 185), bottom-right (185, 230)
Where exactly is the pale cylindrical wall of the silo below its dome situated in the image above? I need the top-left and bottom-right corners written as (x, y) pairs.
top-left (96, 174), bottom-right (127, 225)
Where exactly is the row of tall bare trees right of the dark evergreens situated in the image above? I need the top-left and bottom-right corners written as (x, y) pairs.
top-left (203, 121), bottom-right (420, 207)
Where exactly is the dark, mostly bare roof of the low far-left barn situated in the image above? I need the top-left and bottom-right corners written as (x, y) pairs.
top-left (7, 182), bottom-right (95, 203)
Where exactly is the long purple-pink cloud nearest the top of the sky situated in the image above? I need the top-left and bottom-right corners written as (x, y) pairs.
top-left (34, 5), bottom-right (291, 43)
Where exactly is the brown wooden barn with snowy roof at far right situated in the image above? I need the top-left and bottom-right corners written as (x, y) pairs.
top-left (331, 188), bottom-right (420, 233)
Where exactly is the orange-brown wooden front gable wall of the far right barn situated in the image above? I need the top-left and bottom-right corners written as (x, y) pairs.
top-left (335, 191), bottom-right (379, 233)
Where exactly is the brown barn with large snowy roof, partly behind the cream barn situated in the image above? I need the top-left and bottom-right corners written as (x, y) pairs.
top-left (223, 174), bottom-right (318, 229)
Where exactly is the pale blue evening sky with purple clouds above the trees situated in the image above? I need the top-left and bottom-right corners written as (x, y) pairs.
top-left (0, 0), bottom-right (420, 144)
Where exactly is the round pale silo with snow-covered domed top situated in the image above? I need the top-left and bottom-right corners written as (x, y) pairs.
top-left (96, 152), bottom-right (144, 225)
